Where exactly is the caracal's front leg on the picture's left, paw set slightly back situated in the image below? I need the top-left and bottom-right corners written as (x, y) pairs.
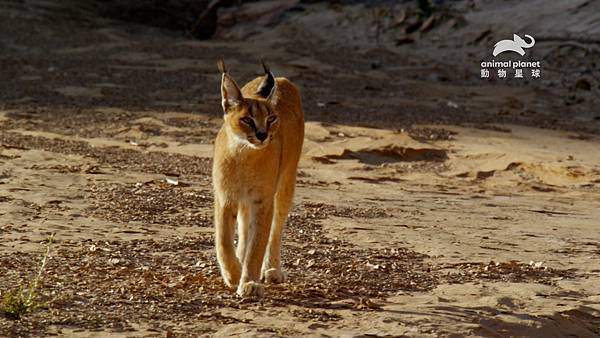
top-left (215, 197), bottom-right (241, 288)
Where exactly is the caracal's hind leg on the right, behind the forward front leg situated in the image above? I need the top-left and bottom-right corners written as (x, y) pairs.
top-left (261, 172), bottom-right (296, 283)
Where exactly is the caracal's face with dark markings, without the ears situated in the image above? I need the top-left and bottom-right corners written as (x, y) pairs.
top-left (225, 99), bottom-right (279, 149)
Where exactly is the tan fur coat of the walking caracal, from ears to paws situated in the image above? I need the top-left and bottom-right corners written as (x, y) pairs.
top-left (213, 64), bottom-right (304, 297)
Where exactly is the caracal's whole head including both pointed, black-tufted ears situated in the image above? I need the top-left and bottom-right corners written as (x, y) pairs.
top-left (219, 60), bottom-right (279, 149)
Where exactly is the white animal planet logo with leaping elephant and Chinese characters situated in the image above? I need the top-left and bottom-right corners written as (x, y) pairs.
top-left (481, 34), bottom-right (541, 78)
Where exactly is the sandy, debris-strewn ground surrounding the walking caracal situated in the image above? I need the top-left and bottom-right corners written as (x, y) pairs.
top-left (0, 1), bottom-right (600, 337)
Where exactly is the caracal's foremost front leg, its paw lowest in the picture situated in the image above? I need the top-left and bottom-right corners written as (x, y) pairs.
top-left (237, 198), bottom-right (273, 298)
